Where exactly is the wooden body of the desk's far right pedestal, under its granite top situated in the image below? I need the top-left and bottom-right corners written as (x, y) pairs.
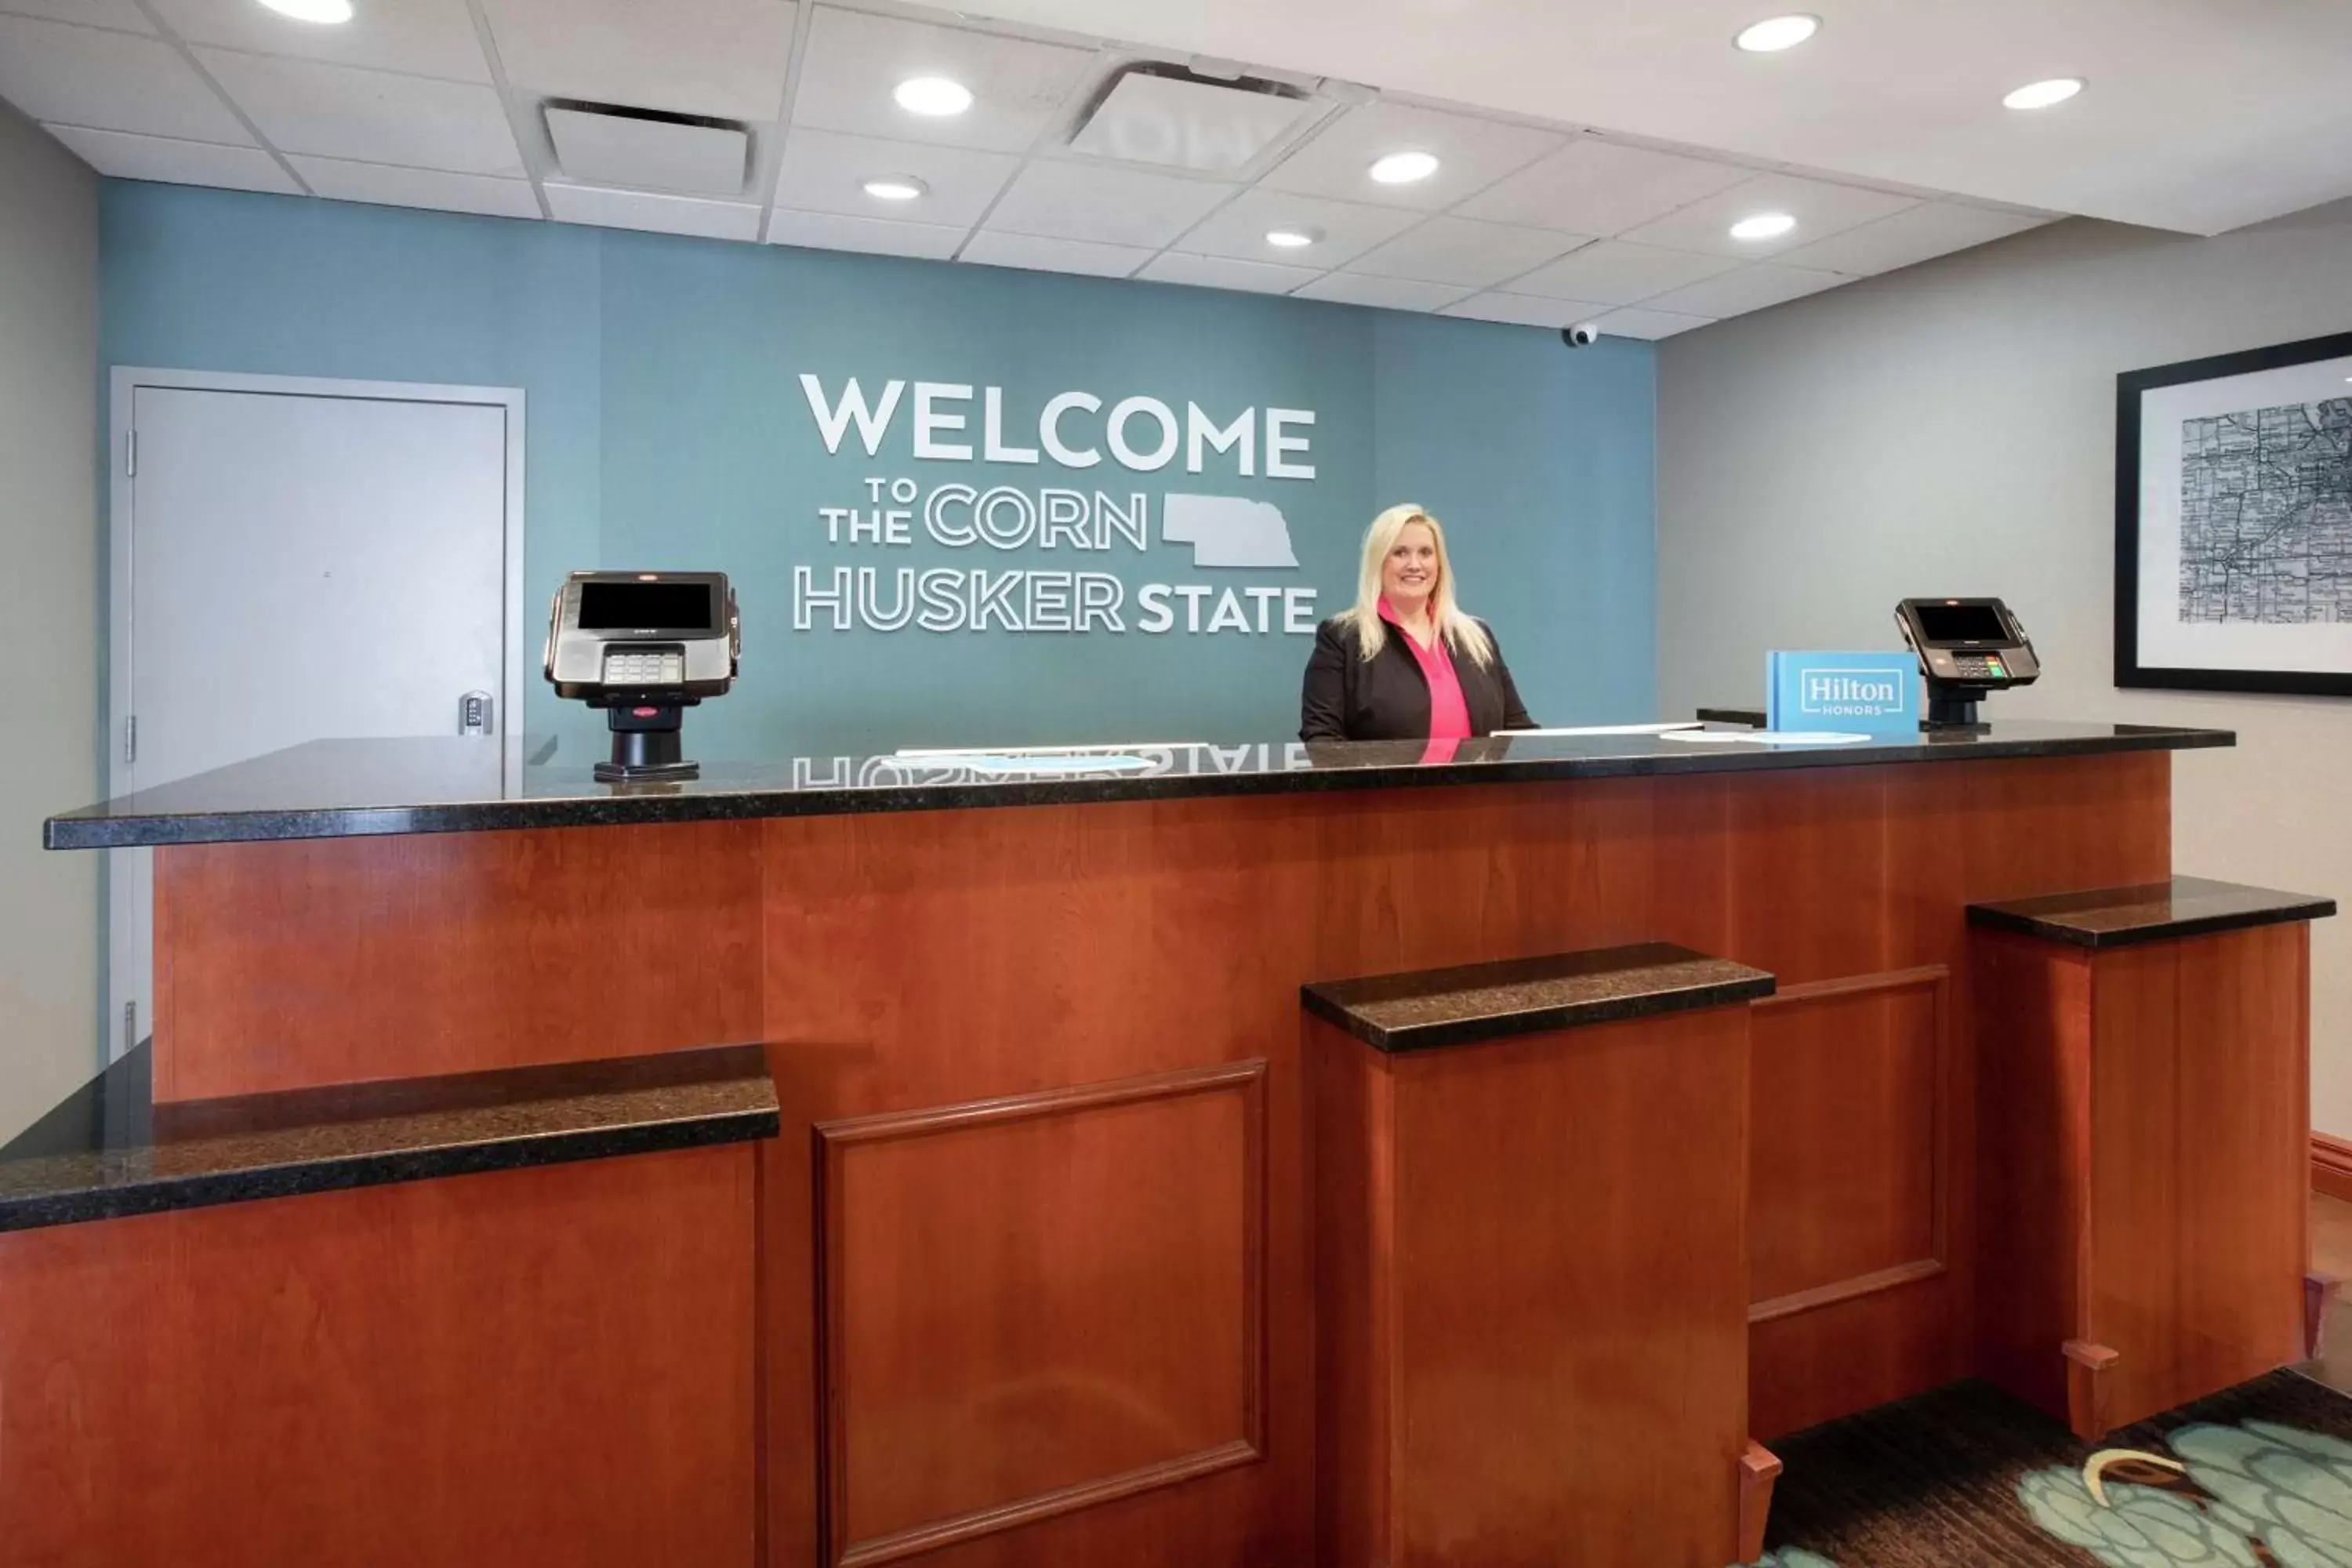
top-left (1973, 924), bottom-right (2310, 1439)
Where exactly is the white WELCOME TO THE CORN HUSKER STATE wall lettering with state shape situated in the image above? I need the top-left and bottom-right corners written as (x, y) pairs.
top-left (793, 374), bottom-right (1315, 637)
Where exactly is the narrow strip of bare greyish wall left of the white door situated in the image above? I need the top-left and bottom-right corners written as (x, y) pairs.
top-left (0, 103), bottom-right (103, 1138)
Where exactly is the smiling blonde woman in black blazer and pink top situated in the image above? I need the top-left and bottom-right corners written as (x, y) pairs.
top-left (1298, 506), bottom-right (1536, 741)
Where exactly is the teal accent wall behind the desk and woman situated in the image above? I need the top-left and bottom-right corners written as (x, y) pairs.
top-left (99, 181), bottom-right (1656, 757)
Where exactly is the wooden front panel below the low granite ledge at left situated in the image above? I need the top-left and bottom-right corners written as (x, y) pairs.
top-left (0, 1145), bottom-right (757, 1568)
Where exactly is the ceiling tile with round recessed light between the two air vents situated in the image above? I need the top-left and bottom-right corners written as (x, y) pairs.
top-left (793, 5), bottom-right (1096, 153)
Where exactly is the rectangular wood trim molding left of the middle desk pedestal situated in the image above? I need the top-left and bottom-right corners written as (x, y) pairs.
top-left (811, 1058), bottom-right (1270, 1568)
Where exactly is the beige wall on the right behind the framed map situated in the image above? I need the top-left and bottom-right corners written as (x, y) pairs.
top-left (1658, 202), bottom-right (2352, 1135)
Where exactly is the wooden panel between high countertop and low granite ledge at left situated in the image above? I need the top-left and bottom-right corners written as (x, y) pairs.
top-left (155, 822), bottom-right (760, 1102)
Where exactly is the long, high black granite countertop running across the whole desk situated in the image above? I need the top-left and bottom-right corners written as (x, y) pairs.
top-left (42, 722), bottom-right (2237, 848)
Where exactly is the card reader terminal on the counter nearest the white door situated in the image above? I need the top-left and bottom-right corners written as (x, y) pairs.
top-left (546, 572), bottom-right (743, 783)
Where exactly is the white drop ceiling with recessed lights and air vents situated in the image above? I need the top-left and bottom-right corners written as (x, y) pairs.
top-left (13, 0), bottom-right (2296, 339)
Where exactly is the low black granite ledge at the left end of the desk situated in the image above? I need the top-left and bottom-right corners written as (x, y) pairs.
top-left (0, 1046), bottom-right (779, 1229)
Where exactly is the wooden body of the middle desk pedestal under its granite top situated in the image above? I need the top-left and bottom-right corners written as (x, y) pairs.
top-left (1310, 1006), bottom-right (1748, 1568)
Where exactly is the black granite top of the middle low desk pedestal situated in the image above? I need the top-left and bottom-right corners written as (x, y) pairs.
top-left (1298, 942), bottom-right (1773, 1051)
